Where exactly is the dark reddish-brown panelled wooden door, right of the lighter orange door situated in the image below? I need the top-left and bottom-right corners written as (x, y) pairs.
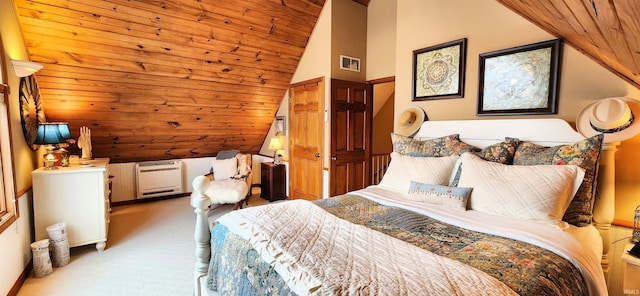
top-left (329, 79), bottom-right (373, 196)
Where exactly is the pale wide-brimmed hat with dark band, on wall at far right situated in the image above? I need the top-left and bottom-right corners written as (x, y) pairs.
top-left (576, 97), bottom-right (640, 143)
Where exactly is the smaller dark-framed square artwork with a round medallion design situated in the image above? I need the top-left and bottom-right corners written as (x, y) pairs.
top-left (411, 38), bottom-right (467, 101)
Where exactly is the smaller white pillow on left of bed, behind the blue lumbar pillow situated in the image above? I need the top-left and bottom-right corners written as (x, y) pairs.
top-left (378, 152), bottom-right (458, 193)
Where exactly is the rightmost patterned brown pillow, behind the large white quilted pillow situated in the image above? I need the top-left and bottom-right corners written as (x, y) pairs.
top-left (513, 134), bottom-right (604, 227)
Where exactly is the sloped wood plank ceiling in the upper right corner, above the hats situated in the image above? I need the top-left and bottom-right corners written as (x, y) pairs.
top-left (497, 0), bottom-right (640, 88)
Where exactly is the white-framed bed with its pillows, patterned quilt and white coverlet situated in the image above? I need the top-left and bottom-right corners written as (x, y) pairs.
top-left (192, 119), bottom-right (613, 295)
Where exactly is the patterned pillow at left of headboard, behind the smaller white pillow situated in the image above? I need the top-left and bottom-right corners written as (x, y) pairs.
top-left (391, 133), bottom-right (480, 157)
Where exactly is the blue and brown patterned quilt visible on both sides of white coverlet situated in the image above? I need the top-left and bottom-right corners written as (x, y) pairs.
top-left (207, 195), bottom-right (589, 295)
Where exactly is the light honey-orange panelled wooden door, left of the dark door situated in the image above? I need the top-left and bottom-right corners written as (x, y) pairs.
top-left (289, 78), bottom-right (324, 200)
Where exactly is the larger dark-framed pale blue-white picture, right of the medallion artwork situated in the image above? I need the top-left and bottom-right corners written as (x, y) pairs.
top-left (477, 39), bottom-right (562, 115)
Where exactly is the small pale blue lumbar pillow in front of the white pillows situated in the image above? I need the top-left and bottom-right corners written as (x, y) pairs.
top-left (408, 181), bottom-right (471, 211)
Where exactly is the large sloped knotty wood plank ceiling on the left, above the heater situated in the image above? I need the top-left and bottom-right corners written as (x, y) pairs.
top-left (15, 0), bottom-right (325, 162)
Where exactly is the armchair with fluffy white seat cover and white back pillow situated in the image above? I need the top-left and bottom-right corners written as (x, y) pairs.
top-left (191, 153), bottom-right (251, 209)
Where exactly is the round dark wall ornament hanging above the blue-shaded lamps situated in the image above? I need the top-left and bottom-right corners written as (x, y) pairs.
top-left (19, 75), bottom-right (46, 151)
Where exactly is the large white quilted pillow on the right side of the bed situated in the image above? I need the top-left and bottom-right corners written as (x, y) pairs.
top-left (458, 153), bottom-right (584, 228)
